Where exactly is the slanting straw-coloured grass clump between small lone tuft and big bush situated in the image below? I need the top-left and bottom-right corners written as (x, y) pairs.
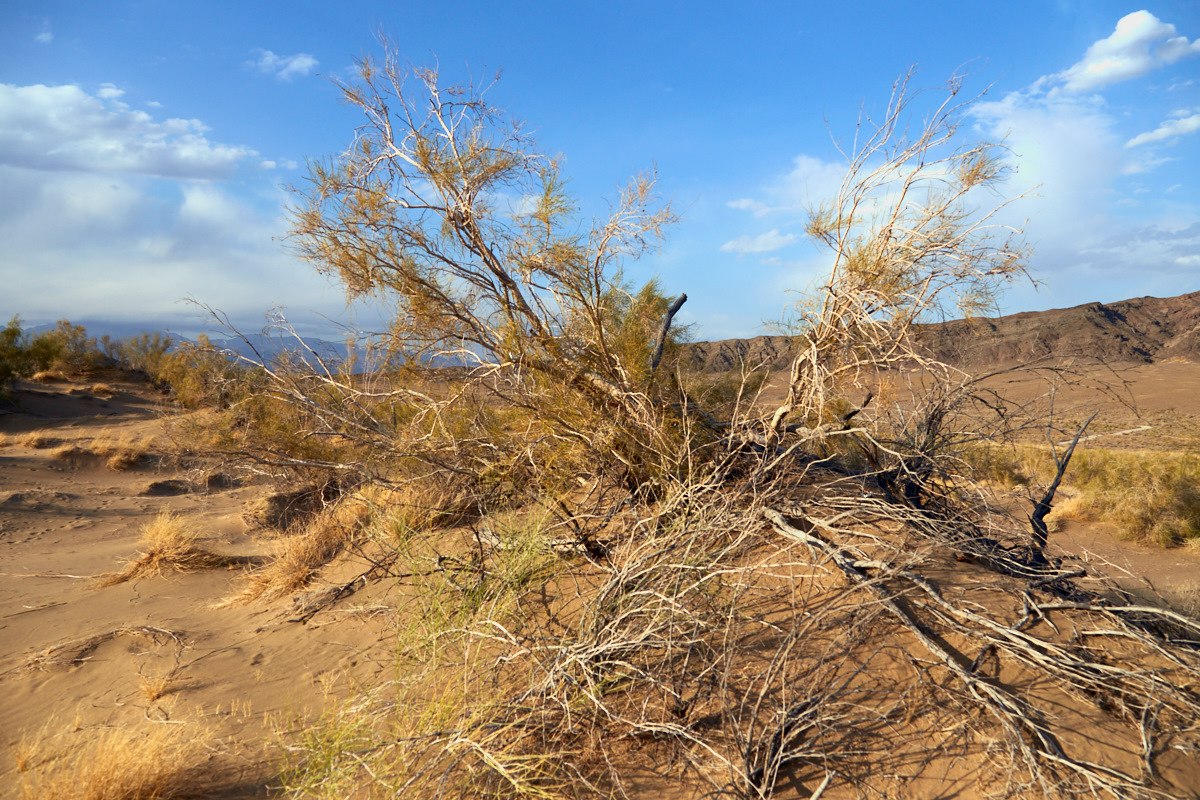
top-left (227, 498), bottom-right (371, 602)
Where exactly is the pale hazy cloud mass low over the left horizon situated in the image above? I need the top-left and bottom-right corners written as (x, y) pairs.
top-left (0, 166), bottom-right (344, 327)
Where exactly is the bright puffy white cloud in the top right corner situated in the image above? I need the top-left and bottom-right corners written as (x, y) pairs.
top-left (1054, 11), bottom-right (1200, 92)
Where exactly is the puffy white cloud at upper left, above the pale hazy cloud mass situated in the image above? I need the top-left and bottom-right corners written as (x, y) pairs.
top-left (0, 84), bottom-right (258, 179)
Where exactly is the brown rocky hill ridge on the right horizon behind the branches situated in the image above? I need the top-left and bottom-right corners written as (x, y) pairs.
top-left (682, 291), bottom-right (1200, 373)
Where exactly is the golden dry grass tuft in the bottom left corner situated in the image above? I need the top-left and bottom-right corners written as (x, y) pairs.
top-left (18, 724), bottom-right (208, 800)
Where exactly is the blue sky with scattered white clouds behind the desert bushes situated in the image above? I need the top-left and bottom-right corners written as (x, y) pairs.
top-left (0, 0), bottom-right (1200, 339)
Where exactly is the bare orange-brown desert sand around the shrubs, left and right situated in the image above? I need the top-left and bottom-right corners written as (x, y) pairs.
top-left (0, 352), bottom-right (1200, 798)
